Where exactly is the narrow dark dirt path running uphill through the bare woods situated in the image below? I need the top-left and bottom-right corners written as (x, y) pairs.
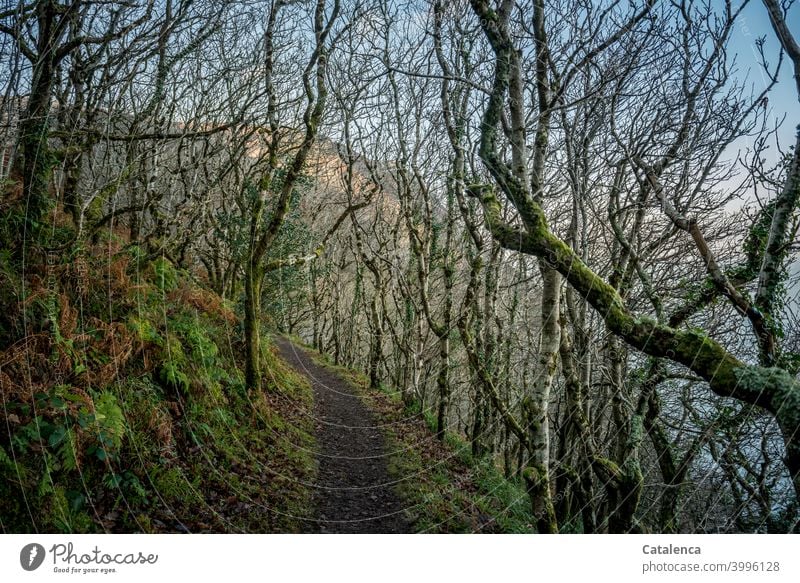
top-left (275, 338), bottom-right (411, 533)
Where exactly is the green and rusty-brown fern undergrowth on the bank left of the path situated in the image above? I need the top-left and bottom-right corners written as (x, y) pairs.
top-left (0, 229), bottom-right (316, 533)
